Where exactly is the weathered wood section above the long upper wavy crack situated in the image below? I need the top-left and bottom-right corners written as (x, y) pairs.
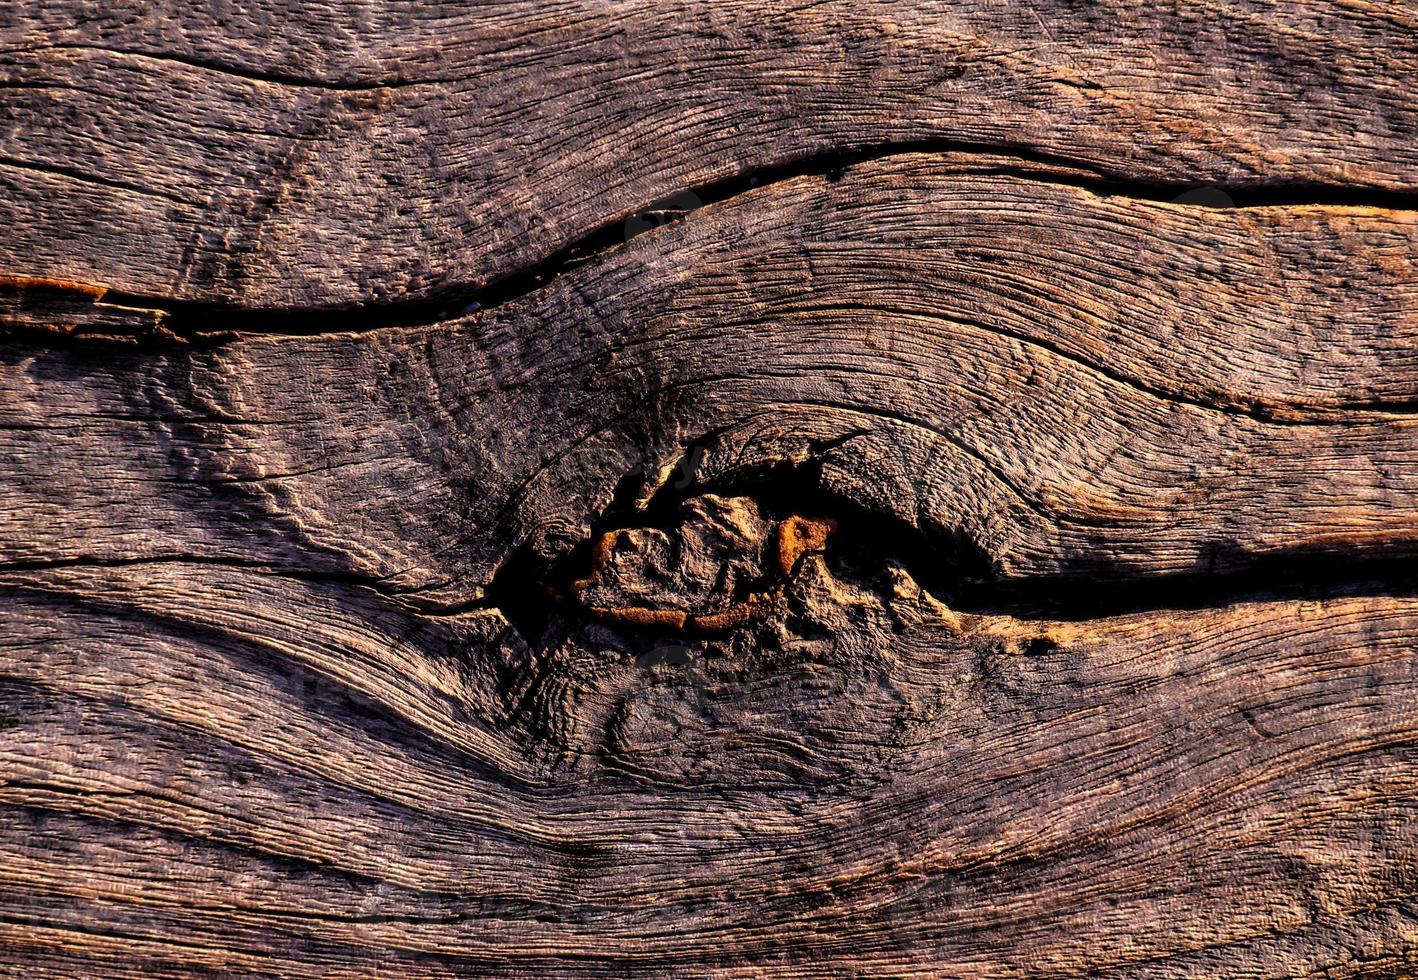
top-left (0, 0), bottom-right (1418, 308)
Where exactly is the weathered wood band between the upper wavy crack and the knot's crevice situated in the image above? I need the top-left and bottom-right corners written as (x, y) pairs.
top-left (0, 155), bottom-right (1418, 604)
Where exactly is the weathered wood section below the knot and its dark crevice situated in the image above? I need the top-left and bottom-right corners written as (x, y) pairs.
top-left (0, 566), bottom-right (1418, 977)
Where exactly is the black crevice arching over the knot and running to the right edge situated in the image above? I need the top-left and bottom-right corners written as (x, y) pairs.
top-left (486, 457), bottom-right (1418, 647)
